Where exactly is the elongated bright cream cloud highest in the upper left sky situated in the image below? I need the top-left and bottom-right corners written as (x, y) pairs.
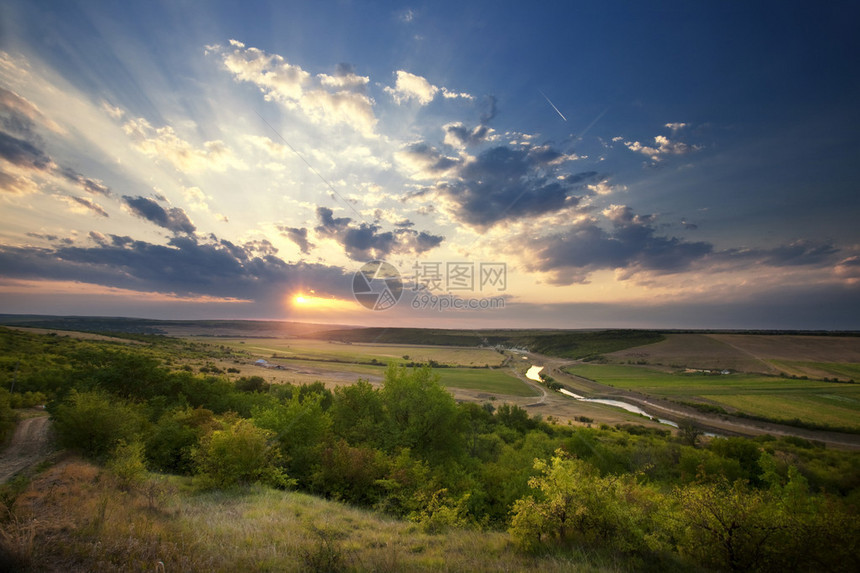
top-left (206, 40), bottom-right (377, 137)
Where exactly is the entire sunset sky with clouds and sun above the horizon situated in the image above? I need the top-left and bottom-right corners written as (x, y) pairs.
top-left (0, 0), bottom-right (860, 330)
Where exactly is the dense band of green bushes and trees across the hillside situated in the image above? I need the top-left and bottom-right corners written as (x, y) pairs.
top-left (0, 332), bottom-right (860, 571)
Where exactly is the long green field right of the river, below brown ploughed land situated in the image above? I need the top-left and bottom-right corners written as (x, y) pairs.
top-left (566, 365), bottom-right (860, 429)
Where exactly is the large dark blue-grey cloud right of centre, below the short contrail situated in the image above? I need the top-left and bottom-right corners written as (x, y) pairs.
top-left (436, 146), bottom-right (600, 229)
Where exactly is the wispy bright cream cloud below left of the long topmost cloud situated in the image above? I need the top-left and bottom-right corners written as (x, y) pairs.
top-left (122, 117), bottom-right (248, 172)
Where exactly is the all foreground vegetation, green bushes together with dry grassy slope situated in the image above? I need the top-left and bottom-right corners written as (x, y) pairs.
top-left (0, 329), bottom-right (860, 571)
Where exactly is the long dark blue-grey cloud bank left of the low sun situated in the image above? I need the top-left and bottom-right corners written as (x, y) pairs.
top-left (0, 232), bottom-right (351, 304)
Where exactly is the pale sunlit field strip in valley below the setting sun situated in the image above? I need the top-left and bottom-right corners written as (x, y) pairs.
top-left (195, 338), bottom-right (505, 367)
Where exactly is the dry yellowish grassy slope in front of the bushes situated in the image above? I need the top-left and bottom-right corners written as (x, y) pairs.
top-left (0, 458), bottom-right (624, 571)
